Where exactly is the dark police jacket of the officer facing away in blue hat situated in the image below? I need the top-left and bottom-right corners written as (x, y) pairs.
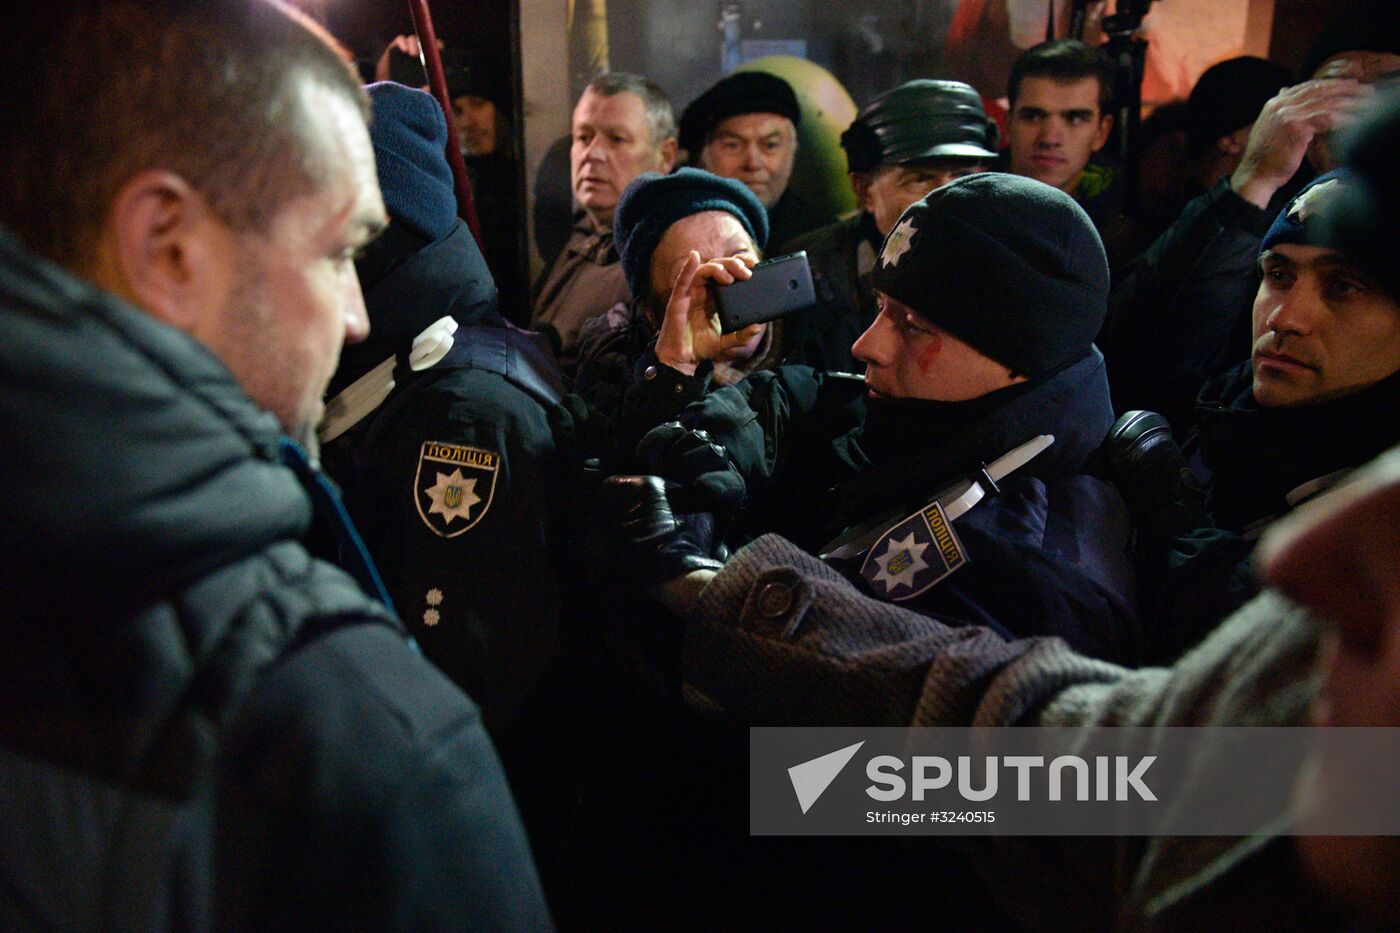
top-left (325, 221), bottom-right (561, 730)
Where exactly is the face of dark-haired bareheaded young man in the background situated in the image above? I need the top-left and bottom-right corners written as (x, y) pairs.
top-left (1007, 77), bottom-right (1113, 193)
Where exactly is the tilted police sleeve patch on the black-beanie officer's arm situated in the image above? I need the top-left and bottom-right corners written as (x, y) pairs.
top-left (861, 502), bottom-right (967, 602)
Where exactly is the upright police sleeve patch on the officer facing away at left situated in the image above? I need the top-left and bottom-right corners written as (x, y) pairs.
top-left (413, 441), bottom-right (501, 538)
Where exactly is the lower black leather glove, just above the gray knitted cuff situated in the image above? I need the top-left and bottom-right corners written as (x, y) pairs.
top-left (585, 476), bottom-right (724, 590)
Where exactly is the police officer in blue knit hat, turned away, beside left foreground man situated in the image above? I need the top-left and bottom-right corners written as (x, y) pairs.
top-left (321, 81), bottom-right (561, 730)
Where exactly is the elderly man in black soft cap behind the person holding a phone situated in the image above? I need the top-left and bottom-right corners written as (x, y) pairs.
top-left (680, 71), bottom-right (802, 242)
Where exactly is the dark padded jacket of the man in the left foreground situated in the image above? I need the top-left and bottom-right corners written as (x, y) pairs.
top-left (0, 234), bottom-right (549, 930)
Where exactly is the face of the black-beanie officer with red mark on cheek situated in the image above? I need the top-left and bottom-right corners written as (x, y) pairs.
top-left (851, 291), bottom-right (1021, 402)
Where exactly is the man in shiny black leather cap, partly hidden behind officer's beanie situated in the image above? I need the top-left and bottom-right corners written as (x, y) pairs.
top-left (783, 78), bottom-right (997, 353)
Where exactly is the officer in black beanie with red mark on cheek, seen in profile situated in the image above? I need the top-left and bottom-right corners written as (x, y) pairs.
top-left (630, 174), bottom-right (1138, 658)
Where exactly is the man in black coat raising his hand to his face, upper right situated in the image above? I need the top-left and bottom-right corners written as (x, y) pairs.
top-left (1099, 0), bottom-right (1400, 428)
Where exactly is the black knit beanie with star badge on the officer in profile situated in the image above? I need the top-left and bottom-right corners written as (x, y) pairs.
top-left (872, 172), bottom-right (1109, 378)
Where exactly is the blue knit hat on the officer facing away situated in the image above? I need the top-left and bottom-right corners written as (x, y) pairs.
top-left (365, 81), bottom-right (456, 240)
